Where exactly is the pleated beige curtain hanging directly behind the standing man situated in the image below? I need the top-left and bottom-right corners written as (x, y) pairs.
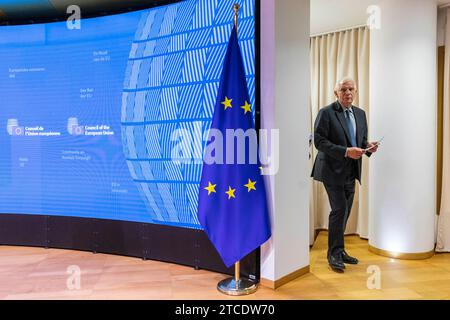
top-left (310, 27), bottom-right (370, 244)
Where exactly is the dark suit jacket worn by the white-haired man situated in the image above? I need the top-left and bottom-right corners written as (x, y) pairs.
top-left (311, 101), bottom-right (370, 185)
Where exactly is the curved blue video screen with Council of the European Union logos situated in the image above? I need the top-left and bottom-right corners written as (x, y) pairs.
top-left (0, 0), bottom-right (255, 228)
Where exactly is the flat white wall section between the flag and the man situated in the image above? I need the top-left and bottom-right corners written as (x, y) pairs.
top-left (261, 0), bottom-right (310, 281)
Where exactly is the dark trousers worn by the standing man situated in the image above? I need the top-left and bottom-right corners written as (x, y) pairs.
top-left (324, 162), bottom-right (355, 256)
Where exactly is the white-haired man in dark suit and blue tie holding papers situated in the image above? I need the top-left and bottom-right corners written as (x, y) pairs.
top-left (312, 78), bottom-right (378, 272)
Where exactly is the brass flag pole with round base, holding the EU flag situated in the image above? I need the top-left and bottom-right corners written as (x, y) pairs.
top-left (217, 3), bottom-right (258, 296)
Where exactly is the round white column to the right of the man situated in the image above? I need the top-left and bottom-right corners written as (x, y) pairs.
top-left (369, 0), bottom-right (437, 254)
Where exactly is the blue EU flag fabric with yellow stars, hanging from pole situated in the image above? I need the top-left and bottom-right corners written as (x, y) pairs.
top-left (198, 28), bottom-right (271, 267)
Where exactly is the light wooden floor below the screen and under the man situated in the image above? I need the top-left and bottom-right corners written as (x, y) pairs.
top-left (0, 232), bottom-right (450, 300)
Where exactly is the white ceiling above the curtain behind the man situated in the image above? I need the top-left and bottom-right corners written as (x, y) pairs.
top-left (311, 0), bottom-right (450, 34)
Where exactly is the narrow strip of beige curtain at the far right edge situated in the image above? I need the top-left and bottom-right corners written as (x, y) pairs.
top-left (436, 9), bottom-right (450, 252)
